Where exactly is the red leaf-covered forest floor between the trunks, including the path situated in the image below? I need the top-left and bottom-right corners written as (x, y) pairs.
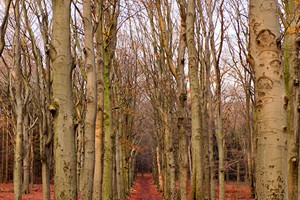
top-left (0, 174), bottom-right (253, 200)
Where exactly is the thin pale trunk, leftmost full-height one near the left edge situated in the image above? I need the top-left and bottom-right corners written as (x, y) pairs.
top-left (14, 0), bottom-right (23, 200)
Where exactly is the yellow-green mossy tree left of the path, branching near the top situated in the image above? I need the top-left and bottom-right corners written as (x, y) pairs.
top-left (100, 1), bottom-right (120, 200)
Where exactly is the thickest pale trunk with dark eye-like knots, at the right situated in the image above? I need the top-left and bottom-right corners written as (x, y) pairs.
top-left (249, 0), bottom-right (288, 199)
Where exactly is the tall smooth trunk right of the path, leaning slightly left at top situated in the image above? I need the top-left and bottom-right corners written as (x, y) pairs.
top-left (186, 0), bottom-right (203, 200)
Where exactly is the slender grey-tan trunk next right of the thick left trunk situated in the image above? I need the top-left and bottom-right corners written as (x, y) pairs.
top-left (80, 0), bottom-right (97, 199)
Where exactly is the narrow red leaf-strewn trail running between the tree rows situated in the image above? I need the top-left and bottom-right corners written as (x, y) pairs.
top-left (127, 174), bottom-right (162, 200)
